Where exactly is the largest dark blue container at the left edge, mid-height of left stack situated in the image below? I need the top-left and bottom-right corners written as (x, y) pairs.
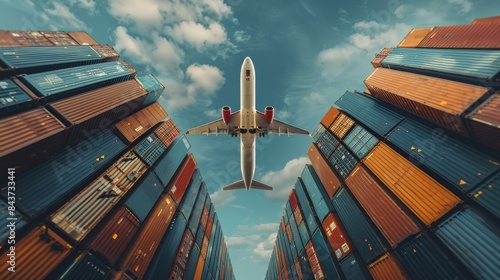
top-left (0, 130), bottom-right (126, 218)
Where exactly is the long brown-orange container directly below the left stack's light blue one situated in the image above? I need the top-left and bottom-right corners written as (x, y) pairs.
top-left (47, 80), bottom-right (146, 143)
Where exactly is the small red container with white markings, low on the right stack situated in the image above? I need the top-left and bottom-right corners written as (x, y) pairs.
top-left (322, 213), bottom-right (353, 260)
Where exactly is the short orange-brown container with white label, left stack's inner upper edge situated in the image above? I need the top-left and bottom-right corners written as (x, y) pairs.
top-left (115, 102), bottom-right (168, 143)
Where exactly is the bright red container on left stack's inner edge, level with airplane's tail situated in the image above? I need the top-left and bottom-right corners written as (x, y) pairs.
top-left (167, 154), bottom-right (196, 205)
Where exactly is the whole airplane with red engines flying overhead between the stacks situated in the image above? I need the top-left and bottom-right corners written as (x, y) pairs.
top-left (186, 57), bottom-right (311, 191)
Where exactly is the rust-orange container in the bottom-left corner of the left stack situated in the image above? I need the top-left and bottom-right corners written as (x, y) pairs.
top-left (0, 226), bottom-right (73, 280)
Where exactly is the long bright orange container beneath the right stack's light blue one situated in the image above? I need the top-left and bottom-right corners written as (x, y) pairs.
top-left (365, 68), bottom-right (490, 136)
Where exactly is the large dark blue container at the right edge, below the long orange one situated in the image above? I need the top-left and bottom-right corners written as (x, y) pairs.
top-left (387, 119), bottom-right (500, 192)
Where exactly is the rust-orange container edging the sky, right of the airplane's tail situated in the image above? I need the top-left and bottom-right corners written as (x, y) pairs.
top-left (307, 143), bottom-right (341, 199)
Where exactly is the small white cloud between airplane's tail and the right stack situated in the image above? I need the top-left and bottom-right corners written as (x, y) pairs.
top-left (261, 157), bottom-right (310, 200)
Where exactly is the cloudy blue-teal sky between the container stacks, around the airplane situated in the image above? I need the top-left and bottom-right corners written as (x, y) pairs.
top-left (0, 0), bottom-right (500, 280)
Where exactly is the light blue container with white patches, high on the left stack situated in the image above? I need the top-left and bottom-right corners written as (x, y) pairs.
top-left (20, 61), bottom-right (135, 101)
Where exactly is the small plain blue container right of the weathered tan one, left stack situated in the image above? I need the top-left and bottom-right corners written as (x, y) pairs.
top-left (125, 172), bottom-right (165, 222)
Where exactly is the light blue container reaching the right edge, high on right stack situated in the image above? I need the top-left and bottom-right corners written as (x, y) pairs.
top-left (382, 48), bottom-right (500, 81)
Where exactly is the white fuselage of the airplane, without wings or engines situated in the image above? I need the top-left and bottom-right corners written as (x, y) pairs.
top-left (240, 57), bottom-right (257, 190)
